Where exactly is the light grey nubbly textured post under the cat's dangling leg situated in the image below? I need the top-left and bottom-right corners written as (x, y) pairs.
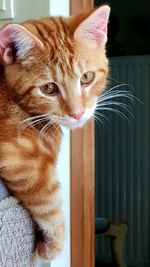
top-left (0, 180), bottom-right (37, 267)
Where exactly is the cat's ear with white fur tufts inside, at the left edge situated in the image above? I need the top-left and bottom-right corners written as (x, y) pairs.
top-left (0, 24), bottom-right (43, 65)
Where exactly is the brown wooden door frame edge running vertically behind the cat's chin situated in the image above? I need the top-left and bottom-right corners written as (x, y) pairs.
top-left (70, 0), bottom-right (95, 267)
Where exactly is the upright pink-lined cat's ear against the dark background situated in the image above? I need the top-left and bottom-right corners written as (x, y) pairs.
top-left (74, 5), bottom-right (110, 45)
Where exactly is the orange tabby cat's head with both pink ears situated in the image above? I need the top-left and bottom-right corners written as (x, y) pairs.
top-left (0, 6), bottom-right (110, 128)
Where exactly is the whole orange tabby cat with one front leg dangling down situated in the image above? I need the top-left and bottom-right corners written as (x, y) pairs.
top-left (0, 6), bottom-right (110, 260)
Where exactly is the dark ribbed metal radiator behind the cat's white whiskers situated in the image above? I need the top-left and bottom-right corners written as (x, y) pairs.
top-left (95, 56), bottom-right (150, 267)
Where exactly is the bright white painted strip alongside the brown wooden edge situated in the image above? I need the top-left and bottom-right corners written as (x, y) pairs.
top-left (49, 3), bottom-right (70, 267)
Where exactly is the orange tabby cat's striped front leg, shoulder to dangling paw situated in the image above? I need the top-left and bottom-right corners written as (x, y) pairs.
top-left (0, 126), bottom-right (64, 260)
